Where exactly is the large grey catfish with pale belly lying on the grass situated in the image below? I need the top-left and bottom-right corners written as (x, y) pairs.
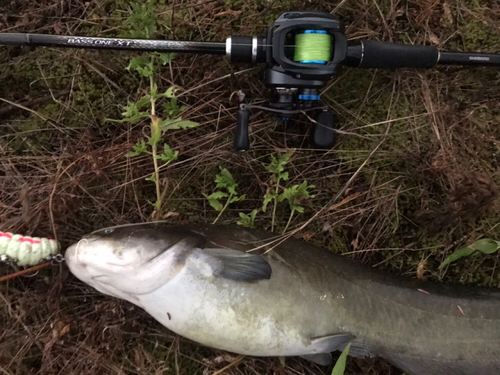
top-left (66, 223), bottom-right (500, 375)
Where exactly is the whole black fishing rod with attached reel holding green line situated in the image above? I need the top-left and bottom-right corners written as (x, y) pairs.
top-left (0, 11), bottom-right (500, 151)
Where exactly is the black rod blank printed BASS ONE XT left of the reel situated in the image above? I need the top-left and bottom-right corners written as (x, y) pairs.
top-left (0, 33), bottom-right (226, 55)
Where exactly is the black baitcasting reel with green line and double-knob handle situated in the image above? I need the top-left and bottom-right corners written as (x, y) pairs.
top-left (234, 12), bottom-right (347, 151)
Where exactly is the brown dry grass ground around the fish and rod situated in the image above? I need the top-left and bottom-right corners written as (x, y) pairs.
top-left (0, 0), bottom-right (500, 375)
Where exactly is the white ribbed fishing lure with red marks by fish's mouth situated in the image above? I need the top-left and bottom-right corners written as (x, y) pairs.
top-left (0, 232), bottom-right (59, 266)
